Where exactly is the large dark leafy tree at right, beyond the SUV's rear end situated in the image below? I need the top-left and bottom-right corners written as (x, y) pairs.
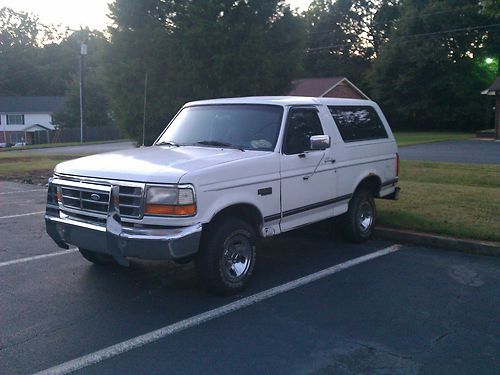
top-left (368, 0), bottom-right (499, 130)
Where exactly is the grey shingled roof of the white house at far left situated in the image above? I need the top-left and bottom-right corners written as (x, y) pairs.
top-left (0, 96), bottom-right (64, 113)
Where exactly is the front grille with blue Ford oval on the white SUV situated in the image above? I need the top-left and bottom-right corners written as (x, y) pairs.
top-left (55, 178), bottom-right (143, 218)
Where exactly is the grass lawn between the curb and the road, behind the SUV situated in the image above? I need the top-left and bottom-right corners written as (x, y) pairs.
top-left (377, 161), bottom-right (500, 242)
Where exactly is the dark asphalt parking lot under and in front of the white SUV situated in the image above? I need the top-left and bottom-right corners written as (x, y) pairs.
top-left (0, 181), bottom-right (500, 374)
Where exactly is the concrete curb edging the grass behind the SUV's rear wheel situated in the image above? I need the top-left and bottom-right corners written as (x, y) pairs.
top-left (374, 226), bottom-right (500, 257)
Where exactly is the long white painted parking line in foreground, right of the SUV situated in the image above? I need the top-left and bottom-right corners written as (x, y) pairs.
top-left (37, 245), bottom-right (401, 374)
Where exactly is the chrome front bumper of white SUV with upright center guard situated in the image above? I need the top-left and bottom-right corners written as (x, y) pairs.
top-left (45, 181), bottom-right (202, 265)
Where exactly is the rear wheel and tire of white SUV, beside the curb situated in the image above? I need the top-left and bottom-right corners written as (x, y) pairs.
top-left (343, 189), bottom-right (377, 243)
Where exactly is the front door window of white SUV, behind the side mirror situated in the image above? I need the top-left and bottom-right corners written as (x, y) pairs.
top-left (283, 108), bottom-right (323, 155)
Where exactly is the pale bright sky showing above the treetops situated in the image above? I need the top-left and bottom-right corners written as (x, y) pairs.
top-left (0, 0), bottom-right (311, 30)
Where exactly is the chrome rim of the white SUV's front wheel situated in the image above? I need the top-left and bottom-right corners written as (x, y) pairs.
top-left (222, 234), bottom-right (252, 281)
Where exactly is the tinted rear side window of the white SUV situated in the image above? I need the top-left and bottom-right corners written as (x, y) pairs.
top-left (328, 106), bottom-right (387, 142)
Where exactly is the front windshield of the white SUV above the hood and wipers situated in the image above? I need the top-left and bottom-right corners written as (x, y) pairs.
top-left (156, 104), bottom-right (283, 151)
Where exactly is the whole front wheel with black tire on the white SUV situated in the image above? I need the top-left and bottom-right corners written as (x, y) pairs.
top-left (195, 217), bottom-right (256, 296)
